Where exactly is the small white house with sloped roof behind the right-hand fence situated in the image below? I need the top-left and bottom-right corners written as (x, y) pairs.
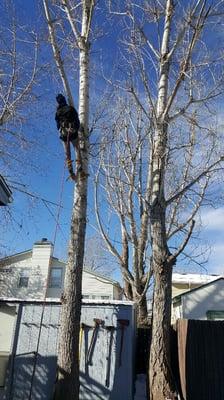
top-left (172, 277), bottom-right (224, 323)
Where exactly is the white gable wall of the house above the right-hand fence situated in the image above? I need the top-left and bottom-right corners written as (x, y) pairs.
top-left (182, 279), bottom-right (224, 319)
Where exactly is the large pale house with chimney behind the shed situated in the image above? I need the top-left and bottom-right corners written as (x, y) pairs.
top-left (0, 238), bottom-right (122, 300)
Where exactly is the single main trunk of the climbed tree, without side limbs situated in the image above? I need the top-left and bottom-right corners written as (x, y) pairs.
top-left (55, 0), bottom-right (91, 400)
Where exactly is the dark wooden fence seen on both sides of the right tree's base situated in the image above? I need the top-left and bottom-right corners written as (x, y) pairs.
top-left (135, 320), bottom-right (224, 400)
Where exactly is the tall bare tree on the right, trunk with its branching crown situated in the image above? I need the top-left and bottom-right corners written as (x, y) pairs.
top-left (103, 0), bottom-right (224, 400)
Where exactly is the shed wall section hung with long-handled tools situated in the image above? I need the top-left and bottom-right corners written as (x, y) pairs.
top-left (80, 305), bottom-right (135, 400)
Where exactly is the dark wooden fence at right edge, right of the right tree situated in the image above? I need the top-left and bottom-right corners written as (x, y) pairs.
top-left (177, 320), bottom-right (224, 400)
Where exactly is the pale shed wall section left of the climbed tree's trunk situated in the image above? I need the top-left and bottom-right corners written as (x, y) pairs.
top-left (9, 305), bottom-right (59, 400)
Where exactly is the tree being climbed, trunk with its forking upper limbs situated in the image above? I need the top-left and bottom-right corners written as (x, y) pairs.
top-left (43, 0), bottom-right (94, 400)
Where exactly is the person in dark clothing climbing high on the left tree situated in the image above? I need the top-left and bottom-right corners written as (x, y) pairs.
top-left (55, 93), bottom-right (82, 180)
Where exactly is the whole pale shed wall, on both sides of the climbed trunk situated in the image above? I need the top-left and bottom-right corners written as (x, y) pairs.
top-left (4, 303), bottom-right (135, 400)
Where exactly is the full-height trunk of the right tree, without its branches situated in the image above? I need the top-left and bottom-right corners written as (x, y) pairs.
top-left (149, 0), bottom-right (177, 400)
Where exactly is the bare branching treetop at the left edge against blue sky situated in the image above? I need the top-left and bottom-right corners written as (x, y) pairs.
top-left (0, 2), bottom-right (38, 175)
